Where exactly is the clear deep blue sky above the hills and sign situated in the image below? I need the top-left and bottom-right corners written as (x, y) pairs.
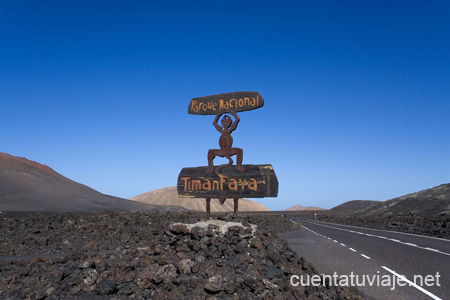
top-left (0, 0), bottom-right (450, 210)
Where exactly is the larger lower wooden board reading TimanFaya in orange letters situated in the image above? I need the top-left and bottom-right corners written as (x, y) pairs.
top-left (177, 165), bottom-right (278, 199)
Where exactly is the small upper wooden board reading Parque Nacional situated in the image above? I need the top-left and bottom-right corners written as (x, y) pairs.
top-left (188, 92), bottom-right (264, 115)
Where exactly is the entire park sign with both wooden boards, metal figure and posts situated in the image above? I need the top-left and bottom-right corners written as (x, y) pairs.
top-left (177, 92), bottom-right (278, 218)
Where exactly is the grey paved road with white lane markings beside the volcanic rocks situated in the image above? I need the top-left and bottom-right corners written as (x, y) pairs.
top-left (281, 219), bottom-right (450, 300)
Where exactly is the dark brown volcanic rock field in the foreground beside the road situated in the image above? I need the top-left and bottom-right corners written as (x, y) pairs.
top-left (0, 212), bottom-right (363, 299)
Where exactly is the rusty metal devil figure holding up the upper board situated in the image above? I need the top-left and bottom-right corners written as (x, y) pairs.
top-left (207, 111), bottom-right (244, 175)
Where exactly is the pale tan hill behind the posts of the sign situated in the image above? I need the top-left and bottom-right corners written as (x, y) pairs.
top-left (131, 186), bottom-right (270, 212)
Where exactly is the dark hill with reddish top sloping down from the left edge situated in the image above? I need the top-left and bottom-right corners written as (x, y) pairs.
top-left (0, 152), bottom-right (185, 212)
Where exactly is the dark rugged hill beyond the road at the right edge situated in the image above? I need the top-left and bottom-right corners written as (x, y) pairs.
top-left (331, 183), bottom-right (450, 215)
